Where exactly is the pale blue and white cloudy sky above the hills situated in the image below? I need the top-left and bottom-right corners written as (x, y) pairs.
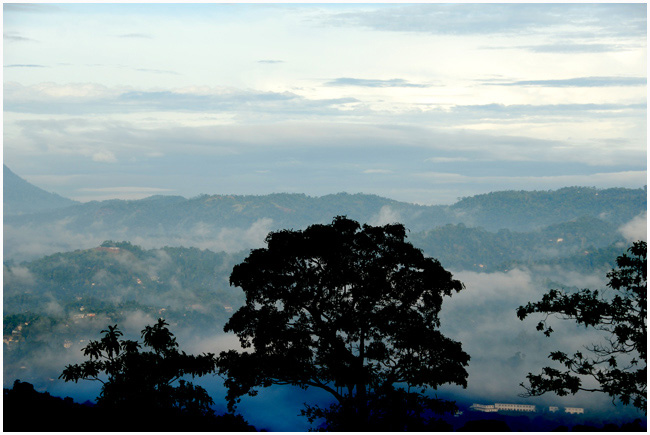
top-left (3, 3), bottom-right (647, 204)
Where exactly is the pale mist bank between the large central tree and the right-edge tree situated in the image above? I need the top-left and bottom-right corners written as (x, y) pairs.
top-left (438, 267), bottom-right (628, 410)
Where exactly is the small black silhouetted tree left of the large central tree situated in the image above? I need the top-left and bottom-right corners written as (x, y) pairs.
top-left (60, 319), bottom-right (216, 415)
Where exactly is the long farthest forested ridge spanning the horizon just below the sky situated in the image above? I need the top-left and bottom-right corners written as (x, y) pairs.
top-left (5, 187), bottom-right (647, 236)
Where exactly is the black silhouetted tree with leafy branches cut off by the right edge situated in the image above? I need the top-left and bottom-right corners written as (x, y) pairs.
top-left (517, 241), bottom-right (648, 411)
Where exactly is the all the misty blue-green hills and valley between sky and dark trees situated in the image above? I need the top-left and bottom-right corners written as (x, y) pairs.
top-left (3, 164), bottom-right (647, 430)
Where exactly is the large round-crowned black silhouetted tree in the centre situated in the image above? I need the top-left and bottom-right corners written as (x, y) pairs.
top-left (219, 217), bottom-right (469, 427)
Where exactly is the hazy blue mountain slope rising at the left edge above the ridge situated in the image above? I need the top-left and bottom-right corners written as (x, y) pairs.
top-left (2, 165), bottom-right (78, 216)
